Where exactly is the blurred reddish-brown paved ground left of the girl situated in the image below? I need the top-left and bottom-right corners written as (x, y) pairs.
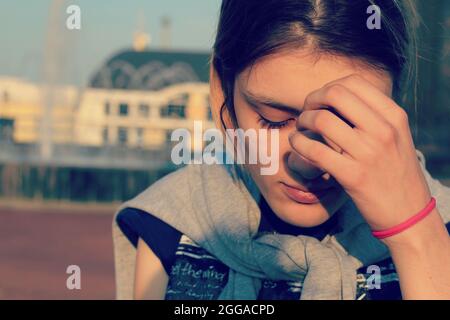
top-left (0, 206), bottom-right (118, 299)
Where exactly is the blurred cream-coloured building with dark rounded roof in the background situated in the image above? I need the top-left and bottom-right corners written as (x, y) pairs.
top-left (0, 48), bottom-right (214, 149)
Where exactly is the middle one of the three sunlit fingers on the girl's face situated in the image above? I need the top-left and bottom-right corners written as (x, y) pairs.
top-left (297, 109), bottom-right (367, 159)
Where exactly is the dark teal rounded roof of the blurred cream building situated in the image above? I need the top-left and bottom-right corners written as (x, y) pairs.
top-left (90, 50), bottom-right (210, 90)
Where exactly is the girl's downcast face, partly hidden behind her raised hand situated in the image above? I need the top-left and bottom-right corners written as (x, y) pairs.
top-left (222, 50), bottom-right (392, 227)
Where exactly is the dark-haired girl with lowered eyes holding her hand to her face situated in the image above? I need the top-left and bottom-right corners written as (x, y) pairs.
top-left (113, 0), bottom-right (450, 299)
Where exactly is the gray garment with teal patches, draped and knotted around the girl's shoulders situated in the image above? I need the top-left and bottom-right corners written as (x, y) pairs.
top-left (113, 152), bottom-right (450, 300)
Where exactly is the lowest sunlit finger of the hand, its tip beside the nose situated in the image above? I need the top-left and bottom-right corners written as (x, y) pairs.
top-left (289, 131), bottom-right (353, 180)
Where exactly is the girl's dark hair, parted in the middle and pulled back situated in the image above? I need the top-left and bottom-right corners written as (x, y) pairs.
top-left (212, 0), bottom-right (417, 127)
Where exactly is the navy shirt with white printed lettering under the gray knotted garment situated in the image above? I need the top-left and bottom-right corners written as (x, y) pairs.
top-left (117, 199), bottom-right (450, 300)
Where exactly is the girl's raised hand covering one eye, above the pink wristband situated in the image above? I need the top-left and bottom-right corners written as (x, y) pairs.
top-left (289, 75), bottom-right (431, 230)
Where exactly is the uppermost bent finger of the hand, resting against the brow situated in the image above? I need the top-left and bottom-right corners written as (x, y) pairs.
top-left (304, 84), bottom-right (389, 135)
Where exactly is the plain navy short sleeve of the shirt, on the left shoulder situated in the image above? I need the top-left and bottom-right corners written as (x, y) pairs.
top-left (116, 208), bottom-right (181, 275)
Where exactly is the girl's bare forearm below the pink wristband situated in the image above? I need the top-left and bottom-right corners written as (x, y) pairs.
top-left (385, 209), bottom-right (450, 299)
